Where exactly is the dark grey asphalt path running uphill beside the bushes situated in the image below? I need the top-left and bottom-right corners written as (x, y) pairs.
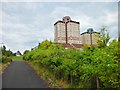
top-left (2, 61), bottom-right (48, 88)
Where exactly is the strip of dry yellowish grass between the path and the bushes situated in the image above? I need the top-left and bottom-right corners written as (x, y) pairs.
top-left (28, 62), bottom-right (69, 88)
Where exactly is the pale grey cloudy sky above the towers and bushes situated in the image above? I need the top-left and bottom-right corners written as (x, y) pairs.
top-left (0, 0), bottom-right (118, 52)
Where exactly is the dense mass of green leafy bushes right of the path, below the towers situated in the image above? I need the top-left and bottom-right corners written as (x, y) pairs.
top-left (23, 27), bottom-right (120, 88)
